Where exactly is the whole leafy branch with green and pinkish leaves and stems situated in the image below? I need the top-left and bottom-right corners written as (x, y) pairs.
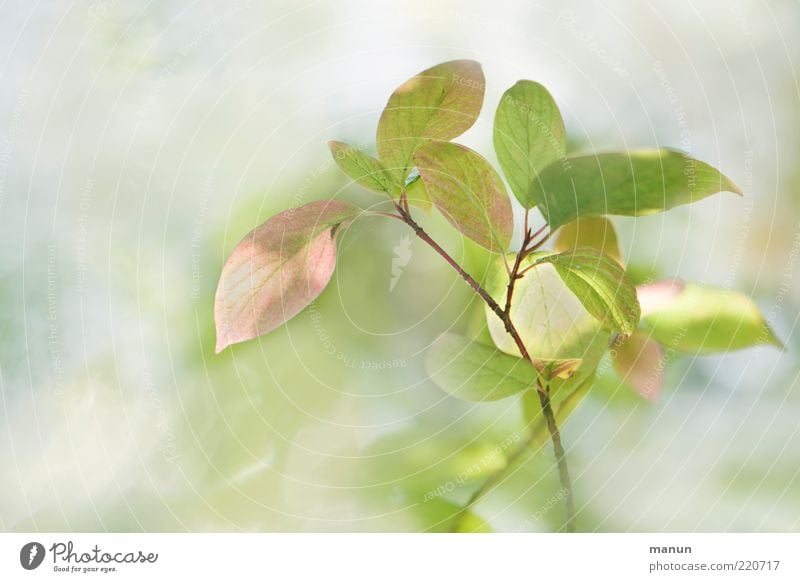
top-left (214, 60), bottom-right (782, 531)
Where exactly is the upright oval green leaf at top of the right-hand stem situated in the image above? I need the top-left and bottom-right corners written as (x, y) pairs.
top-left (494, 81), bottom-right (567, 208)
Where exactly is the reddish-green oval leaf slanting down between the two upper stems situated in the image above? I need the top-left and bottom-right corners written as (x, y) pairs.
top-left (414, 142), bottom-right (514, 253)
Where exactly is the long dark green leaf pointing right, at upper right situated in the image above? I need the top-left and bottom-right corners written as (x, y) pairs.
top-left (531, 149), bottom-right (742, 229)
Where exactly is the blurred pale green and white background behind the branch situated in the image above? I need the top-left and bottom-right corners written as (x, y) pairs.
top-left (0, 0), bottom-right (800, 532)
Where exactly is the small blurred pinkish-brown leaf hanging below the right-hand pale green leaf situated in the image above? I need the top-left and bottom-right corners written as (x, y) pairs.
top-left (611, 332), bottom-right (664, 400)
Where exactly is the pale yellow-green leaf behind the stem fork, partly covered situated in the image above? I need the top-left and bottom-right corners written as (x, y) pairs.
top-left (484, 253), bottom-right (611, 376)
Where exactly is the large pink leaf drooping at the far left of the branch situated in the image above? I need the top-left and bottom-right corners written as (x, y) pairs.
top-left (214, 200), bottom-right (361, 352)
